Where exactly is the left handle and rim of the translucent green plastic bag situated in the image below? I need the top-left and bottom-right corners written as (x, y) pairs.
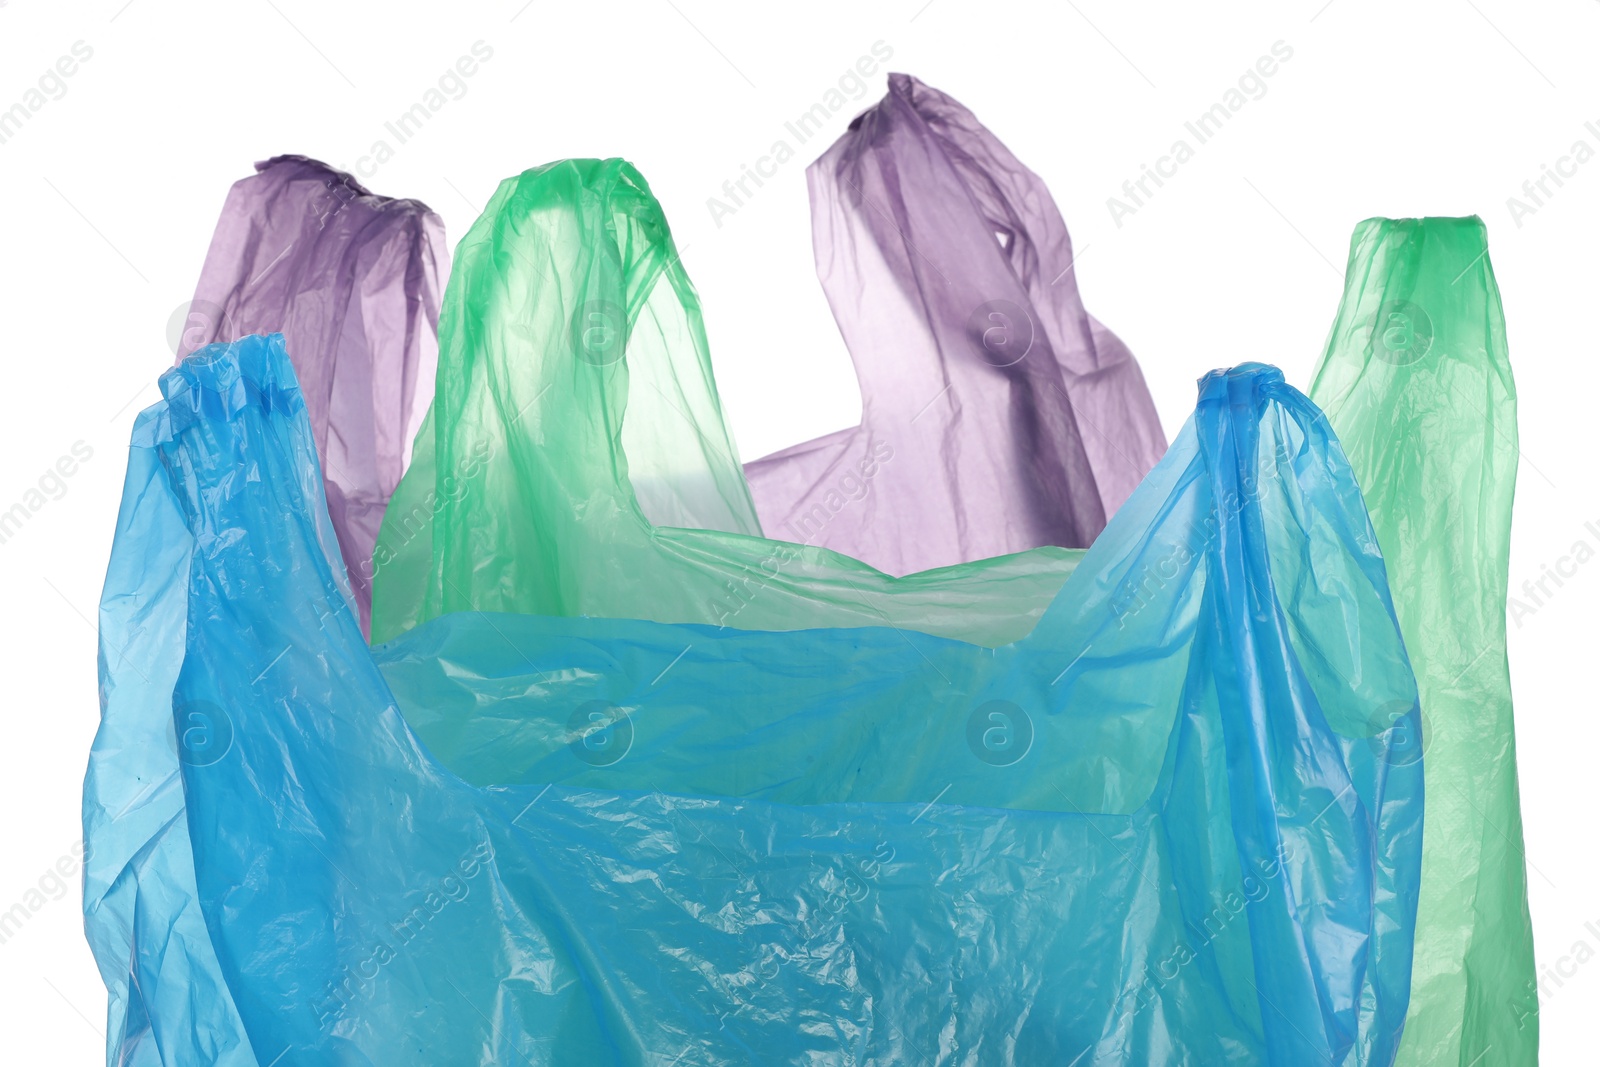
top-left (371, 160), bottom-right (1082, 645)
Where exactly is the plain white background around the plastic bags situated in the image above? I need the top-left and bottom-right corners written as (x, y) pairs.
top-left (0, 0), bottom-right (1600, 1065)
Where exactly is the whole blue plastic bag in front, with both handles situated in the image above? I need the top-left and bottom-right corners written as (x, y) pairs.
top-left (91, 338), bottom-right (1422, 1065)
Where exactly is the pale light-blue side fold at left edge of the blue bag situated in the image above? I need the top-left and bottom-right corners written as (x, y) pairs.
top-left (83, 382), bottom-right (275, 1067)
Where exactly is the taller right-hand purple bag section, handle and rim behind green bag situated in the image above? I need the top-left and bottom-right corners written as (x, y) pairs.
top-left (744, 74), bottom-right (1166, 574)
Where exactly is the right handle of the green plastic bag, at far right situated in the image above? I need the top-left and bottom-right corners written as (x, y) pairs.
top-left (1312, 218), bottom-right (1539, 1067)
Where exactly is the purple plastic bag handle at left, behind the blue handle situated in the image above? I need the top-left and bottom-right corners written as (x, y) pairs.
top-left (178, 155), bottom-right (448, 627)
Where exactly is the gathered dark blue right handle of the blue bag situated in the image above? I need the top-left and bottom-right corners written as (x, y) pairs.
top-left (1195, 365), bottom-right (1422, 1062)
